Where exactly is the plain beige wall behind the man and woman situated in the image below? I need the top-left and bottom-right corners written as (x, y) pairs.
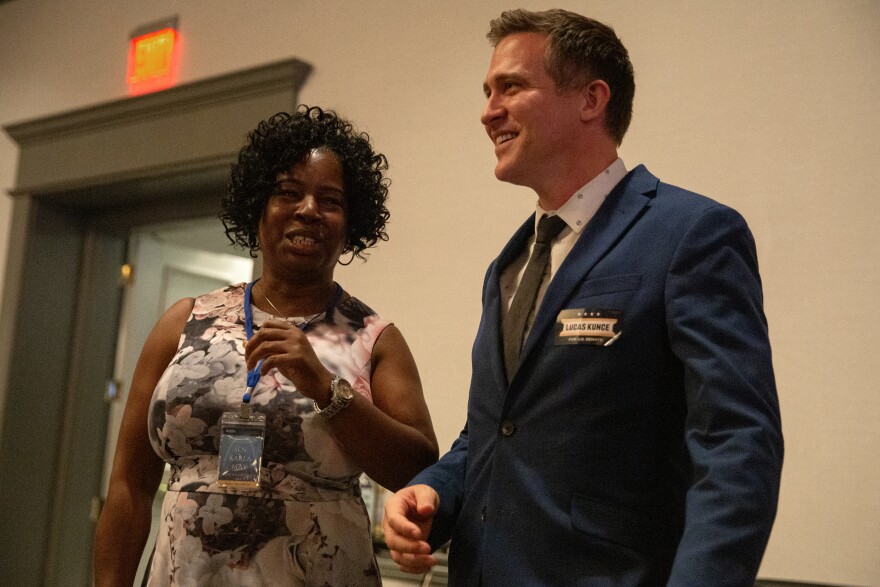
top-left (0, 0), bottom-right (880, 585)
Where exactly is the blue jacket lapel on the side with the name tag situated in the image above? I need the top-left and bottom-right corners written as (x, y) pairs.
top-left (520, 165), bottom-right (658, 373)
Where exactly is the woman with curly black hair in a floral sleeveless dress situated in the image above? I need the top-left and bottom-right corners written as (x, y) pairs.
top-left (95, 106), bottom-right (437, 586)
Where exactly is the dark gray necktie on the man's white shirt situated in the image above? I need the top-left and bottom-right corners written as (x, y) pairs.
top-left (504, 214), bottom-right (565, 381)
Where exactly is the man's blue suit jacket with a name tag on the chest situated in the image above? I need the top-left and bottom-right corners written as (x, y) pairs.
top-left (412, 166), bottom-right (783, 587)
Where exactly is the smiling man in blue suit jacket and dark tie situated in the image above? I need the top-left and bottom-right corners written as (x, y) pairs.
top-left (383, 10), bottom-right (783, 586)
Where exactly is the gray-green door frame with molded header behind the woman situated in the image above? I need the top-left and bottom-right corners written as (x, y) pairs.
top-left (0, 59), bottom-right (311, 586)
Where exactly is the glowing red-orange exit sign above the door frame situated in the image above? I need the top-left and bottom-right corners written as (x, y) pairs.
top-left (126, 17), bottom-right (180, 94)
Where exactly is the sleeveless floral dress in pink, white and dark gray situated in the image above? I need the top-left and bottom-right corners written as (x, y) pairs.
top-left (147, 284), bottom-right (389, 587)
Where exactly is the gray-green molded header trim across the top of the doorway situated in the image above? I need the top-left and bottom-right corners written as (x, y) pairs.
top-left (4, 59), bottom-right (311, 196)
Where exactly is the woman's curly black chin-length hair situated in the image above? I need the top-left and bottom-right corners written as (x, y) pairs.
top-left (220, 105), bottom-right (391, 259)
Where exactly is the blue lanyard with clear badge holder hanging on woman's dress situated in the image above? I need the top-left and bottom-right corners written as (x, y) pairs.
top-left (217, 283), bottom-right (266, 489)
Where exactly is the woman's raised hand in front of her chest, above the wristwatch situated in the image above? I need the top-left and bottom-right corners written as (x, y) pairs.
top-left (244, 320), bottom-right (333, 406)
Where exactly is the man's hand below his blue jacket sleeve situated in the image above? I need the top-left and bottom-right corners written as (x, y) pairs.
top-left (382, 485), bottom-right (440, 574)
